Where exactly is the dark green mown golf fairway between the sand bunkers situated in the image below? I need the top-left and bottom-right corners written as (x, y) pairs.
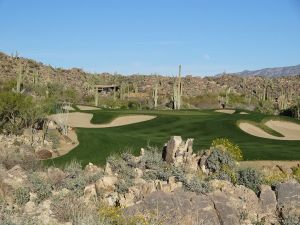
top-left (47, 110), bottom-right (300, 165)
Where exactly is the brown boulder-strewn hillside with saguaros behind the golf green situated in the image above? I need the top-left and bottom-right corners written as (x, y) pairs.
top-left (0, 53), bottom-right (300, 110)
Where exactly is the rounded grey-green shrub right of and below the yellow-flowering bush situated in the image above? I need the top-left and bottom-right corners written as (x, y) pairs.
top-left (237, 168), bottom-right (262, 194)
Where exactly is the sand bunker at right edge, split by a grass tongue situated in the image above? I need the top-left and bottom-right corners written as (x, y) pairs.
top-left (239, 120), bottom-right (300, 141)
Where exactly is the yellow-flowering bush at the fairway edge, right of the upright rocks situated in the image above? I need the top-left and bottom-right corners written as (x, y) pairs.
top-left (211, 138), bottom-right (243, 161)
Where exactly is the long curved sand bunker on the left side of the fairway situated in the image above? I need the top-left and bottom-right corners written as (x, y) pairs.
top-left (51, 112), bottom-right (156, 128)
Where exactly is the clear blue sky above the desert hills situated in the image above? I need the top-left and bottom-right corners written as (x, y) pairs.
top-left (0, 0), bottom-right (300, 75)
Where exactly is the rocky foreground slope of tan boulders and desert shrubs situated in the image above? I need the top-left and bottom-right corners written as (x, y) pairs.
top-left (0, 136), bottom-right (300, 225)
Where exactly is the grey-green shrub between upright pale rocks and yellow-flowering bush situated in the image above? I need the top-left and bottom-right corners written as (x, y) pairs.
top-left (206, 149), bottom-right (236, 173)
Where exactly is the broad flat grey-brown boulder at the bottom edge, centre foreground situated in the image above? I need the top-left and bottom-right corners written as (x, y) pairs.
top-left (125, 191), bottom-right (220, 225)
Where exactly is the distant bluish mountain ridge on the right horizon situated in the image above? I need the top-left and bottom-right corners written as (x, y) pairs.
top-left (233, 64), bottom-right (300, 77)
